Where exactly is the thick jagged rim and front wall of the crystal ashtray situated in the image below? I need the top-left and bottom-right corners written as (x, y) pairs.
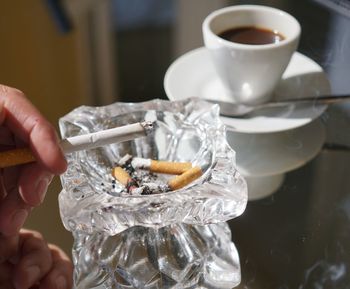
top-left (59, 98), bottom-right (248, 234)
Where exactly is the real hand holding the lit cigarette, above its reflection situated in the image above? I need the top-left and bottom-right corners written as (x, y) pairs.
top-left (0, 85), bottom-right (67, 236)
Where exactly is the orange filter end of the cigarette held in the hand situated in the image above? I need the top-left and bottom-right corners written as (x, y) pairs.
top-left (0, 148), bottom-right (35, 168)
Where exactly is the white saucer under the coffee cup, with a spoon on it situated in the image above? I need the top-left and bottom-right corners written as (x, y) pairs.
top-left (164, 47), bottom-right (330, 133)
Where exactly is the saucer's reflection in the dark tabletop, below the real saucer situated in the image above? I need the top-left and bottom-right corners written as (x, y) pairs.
top-left (227, 119), bottom-right (326, 177)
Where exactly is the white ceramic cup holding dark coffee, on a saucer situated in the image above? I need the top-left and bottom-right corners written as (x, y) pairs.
top-left (202, 5), bottom-right (301, 104)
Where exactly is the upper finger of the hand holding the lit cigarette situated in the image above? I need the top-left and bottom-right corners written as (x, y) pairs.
top-left (0, 85), bottom-right (67, 174)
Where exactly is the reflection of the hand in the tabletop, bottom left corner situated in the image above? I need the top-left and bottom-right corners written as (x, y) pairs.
top-left (0, 229), bottom-right (73, 289)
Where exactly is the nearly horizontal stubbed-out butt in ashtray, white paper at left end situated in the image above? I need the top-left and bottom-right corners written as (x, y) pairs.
top-left (131, 158), bottom-right (192, 175)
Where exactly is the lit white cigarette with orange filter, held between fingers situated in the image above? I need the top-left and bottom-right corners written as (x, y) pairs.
top-left (0, 121), bottom-right (154, 168)
